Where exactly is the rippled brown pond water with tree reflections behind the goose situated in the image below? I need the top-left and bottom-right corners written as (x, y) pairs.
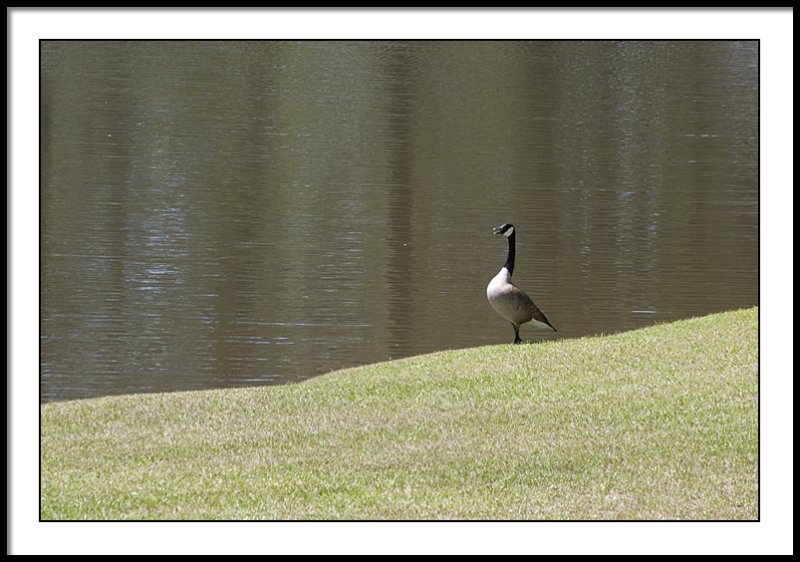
top-left (41, 41), bottom-right (758, 400)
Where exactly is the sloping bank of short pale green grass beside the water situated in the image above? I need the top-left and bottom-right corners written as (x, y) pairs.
top-left (41, 308), bottom-right (758, 519)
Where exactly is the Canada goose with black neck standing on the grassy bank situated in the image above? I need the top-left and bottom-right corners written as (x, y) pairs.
top-left (486, 224), bottom-right (556, 343)
